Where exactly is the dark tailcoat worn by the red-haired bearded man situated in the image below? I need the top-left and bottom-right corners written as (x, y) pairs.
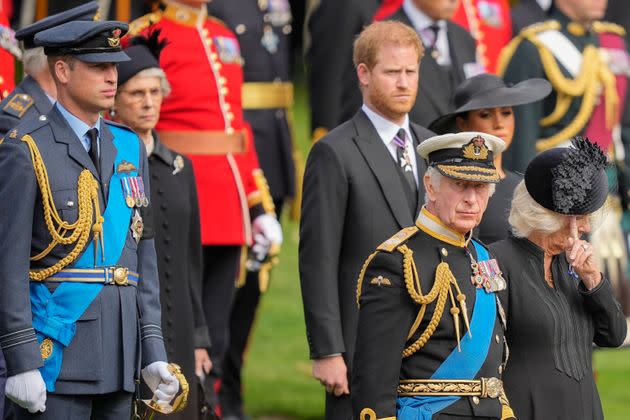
top-left (299, 111), bottom-right (432, 418)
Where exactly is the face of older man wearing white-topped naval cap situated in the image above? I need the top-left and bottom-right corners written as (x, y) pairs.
top-left (424, 175), bottom-right (490, 235)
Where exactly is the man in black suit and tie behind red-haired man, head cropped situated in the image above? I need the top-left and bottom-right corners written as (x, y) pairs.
top-left (388, 0), bottom-right (485, 126)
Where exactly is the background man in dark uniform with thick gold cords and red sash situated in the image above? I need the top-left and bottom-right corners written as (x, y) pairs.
top-left (498, 0), bottom-right (630, 314)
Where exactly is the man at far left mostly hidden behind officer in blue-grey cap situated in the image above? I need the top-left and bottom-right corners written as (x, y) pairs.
top-left (0, 1), bottom-right (98, 137)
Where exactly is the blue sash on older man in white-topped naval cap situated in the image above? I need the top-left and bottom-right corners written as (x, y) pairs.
top-left (396, 240), bottom-right (497, 420)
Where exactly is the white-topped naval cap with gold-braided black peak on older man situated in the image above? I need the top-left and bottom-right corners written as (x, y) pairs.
top-left (417, 131), bottom-right (505, 183)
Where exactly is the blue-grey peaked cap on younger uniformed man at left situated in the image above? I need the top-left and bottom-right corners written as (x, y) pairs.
top-left (35, 21), bottom-right (129, 63)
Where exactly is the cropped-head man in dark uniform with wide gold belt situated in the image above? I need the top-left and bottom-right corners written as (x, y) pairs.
top-left (208, 0), bottom-right (295, 419)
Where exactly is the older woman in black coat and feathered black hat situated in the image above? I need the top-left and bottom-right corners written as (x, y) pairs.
top-left (110, 31), bottom-right (212, 420)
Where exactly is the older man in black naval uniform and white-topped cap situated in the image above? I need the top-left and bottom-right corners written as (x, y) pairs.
top-left (352, 132), bottom-right (514, 420)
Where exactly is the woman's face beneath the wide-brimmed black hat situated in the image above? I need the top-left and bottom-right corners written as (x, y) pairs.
top-left (456, 106), bottom-right (514, 149)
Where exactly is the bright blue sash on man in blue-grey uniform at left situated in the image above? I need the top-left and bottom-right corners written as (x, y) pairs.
top-left (30, 125), bottom-right (140, 392)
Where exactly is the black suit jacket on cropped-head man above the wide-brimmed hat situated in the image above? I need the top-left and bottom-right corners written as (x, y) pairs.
top-left (388, 7), bottom-right (476, 126)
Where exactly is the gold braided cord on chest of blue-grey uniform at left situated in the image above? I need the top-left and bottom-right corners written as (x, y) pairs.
top-left (21, 134), bottom-right (104, 281)
